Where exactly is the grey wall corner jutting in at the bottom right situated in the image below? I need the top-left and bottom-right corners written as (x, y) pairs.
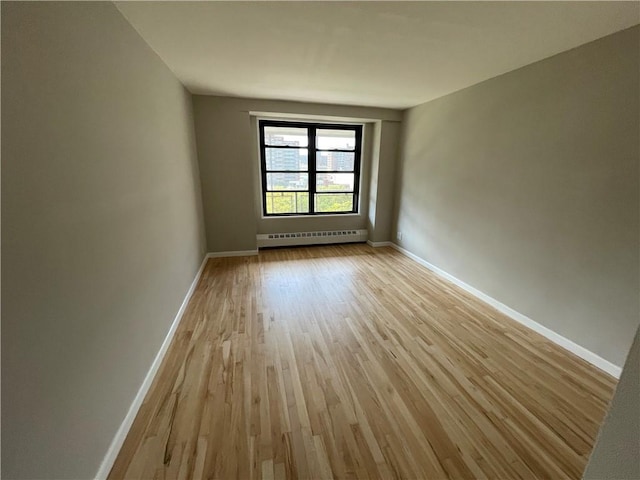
top-left (583, 329), bottom-right (640, 480)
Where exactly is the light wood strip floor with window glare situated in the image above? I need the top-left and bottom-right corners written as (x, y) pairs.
top-left (109, 245), bottom-right (615, 480)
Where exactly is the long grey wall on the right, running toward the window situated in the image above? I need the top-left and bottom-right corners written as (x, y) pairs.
top-left (393, 27), bottom-right (640, 366)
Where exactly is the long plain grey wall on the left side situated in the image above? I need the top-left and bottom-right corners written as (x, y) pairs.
top-left (2, 2), bottom-right (205, 479)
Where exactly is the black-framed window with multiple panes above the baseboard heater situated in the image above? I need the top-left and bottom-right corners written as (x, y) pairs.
top-left (259, 120), bottom-right (362, 216)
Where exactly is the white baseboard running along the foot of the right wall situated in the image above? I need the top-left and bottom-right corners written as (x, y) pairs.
top-left (390, 242), bottom-right (622, 378)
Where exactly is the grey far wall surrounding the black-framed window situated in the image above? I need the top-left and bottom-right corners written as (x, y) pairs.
top-left (193, 95), bottom-right (402, 252)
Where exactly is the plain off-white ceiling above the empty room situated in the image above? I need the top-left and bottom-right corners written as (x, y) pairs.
top-left (116, 1), bottom-right (640, 108)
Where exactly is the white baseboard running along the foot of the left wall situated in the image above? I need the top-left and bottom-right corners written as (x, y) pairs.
top-left (95, 255), bottom-right (209, 480)
